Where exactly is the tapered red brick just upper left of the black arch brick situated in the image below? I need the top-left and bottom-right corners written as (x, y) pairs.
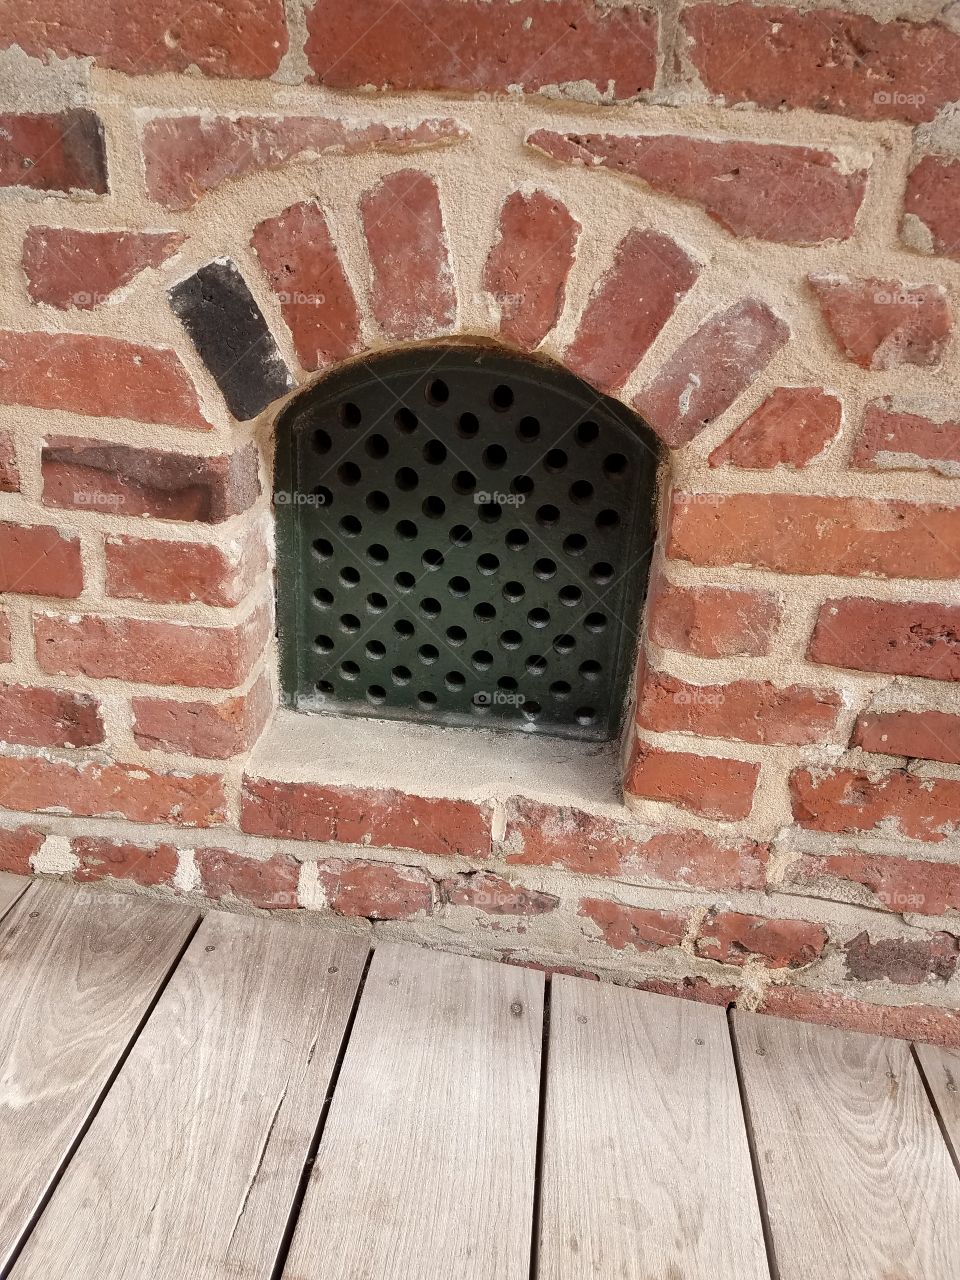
top-left (22, 227), bottom-right (187, 311)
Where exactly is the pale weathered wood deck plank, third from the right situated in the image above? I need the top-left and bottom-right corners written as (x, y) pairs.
top-left (539, 978), bottom-right (769, 1280)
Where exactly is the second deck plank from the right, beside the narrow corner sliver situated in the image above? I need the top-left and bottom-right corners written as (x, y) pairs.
top-left (733, 1014), bottom-right (960, 1280)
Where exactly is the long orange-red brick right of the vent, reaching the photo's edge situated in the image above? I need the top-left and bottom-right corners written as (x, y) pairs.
top-left (667, 493), bottom-right (960, 579)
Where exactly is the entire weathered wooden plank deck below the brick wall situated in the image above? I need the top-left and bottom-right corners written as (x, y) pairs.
top-left (0, 874), bottom-right (960, 1280)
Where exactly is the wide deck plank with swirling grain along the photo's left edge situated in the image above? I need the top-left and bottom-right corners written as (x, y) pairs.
top-left (0, 881), bottom-right (197, 1274)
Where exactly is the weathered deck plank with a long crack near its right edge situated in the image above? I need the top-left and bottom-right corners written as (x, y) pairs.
top-left (14, 913), bottom-right (367, 1280)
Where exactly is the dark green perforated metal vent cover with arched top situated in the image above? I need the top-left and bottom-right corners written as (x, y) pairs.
top-left (274, 346), bottom-right (657, 740)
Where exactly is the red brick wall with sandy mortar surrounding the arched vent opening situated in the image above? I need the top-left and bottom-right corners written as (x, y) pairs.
top-left (0, 0), bottom-right (960, 1044)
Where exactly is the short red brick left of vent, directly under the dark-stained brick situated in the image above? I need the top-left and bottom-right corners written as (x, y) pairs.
top-left (105, 534), bottom-right (266, 605)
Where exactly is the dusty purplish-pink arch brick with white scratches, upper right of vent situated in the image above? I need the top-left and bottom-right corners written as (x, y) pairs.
top-left (634, 298), bottom-right (790, 448)
